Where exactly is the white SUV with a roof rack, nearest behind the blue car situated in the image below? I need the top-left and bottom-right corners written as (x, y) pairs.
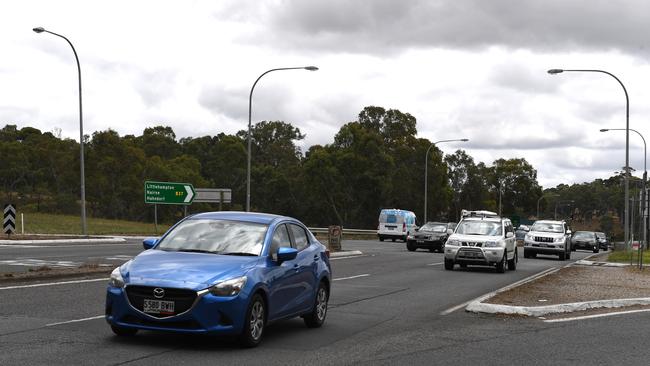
top-left (445, 210), bottom-right (518, 273)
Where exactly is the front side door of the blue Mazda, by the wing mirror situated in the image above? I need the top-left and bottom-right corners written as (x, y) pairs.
top-left (267, 224), bottom-right (304, 319)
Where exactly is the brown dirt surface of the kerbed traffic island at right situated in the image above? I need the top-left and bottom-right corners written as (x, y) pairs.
top-left (484, 265), bottom-right (650, 306)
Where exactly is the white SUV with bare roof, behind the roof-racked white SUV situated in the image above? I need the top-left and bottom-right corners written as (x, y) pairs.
top-left (524, 220), bottom-right (571, 261)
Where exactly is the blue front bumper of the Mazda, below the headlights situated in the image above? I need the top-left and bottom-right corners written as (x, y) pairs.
top-left (106, 287), bottom-right (247, 335)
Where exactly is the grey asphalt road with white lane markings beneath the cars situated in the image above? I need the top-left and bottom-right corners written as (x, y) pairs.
top-left (0, 241), bottom-right (650, 365)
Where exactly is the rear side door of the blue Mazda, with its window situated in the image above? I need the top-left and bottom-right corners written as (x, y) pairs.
top-left (287, 223), bottom-right (321, 311)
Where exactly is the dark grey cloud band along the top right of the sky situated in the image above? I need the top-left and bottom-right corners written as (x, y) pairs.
top-left (217, 0), bottom-right (650, 54)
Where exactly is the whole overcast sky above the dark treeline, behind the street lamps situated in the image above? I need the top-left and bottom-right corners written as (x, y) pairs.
top-left (0, 0), bottom-right (650, 188)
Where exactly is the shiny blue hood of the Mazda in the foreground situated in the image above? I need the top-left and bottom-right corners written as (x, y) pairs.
top-left (121, 250), bottom-right (260, 290)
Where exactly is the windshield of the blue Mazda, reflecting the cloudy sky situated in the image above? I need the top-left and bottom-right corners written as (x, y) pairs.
top-left (156, 219), bottom-right (268, 255)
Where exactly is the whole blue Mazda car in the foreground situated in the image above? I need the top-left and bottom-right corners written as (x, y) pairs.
top-left (106, 212), bottom-right (331, 347)
